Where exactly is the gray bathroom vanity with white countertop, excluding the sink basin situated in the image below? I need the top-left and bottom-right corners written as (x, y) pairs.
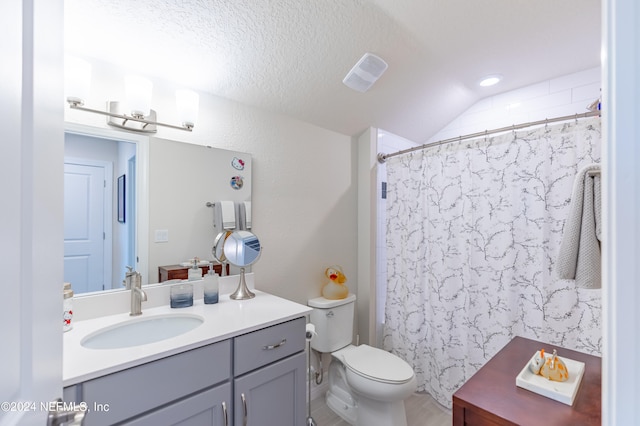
top-left (63, 291), bottom-right (310, 426)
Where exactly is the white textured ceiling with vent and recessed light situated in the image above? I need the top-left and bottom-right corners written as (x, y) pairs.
top-left (65, 0), bottom-right (600, 142)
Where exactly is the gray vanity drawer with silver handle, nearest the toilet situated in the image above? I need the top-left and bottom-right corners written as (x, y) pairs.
top-left (233, 317), bottom-right (306, 376)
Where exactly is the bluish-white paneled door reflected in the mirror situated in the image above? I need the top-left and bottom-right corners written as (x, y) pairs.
top-left (64, 162), bottom-right (111, 293)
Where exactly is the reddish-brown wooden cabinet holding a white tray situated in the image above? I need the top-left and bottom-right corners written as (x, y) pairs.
top-left (453, 337), bottom-right (602, 426)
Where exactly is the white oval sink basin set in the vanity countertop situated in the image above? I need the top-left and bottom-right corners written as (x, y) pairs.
top-left (80, 314), bottom-right (204, 349)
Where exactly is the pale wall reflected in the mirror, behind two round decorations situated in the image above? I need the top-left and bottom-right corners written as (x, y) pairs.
top-left (148, 138), bottom-right (253, 283)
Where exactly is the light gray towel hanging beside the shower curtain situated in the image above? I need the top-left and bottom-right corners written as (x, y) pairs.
top-left (556, 164), bottom-right (602, 289)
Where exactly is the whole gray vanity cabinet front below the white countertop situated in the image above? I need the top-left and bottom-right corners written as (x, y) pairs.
top-left (64, 317), bottom-right (306, 426)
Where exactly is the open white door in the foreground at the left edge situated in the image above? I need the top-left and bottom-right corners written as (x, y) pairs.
top-left (0, 0), bottom-right (64, 426)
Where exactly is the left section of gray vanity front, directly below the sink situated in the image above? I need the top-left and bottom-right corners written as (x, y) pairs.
top-left (65, 340), bottom-right (231, 426)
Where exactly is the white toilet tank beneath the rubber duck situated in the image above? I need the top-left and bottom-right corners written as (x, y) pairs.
top-left (307, 294), bottom-right (356, 353)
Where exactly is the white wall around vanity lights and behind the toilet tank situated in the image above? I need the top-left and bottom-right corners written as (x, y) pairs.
top-left (65, 63), bottom-right (357, 304)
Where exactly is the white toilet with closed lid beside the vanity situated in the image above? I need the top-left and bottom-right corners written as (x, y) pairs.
top-left (308, 294), bottom-right (416, 426)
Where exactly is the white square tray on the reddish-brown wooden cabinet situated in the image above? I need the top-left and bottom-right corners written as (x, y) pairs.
top-left (516, 352), bottom-right (584, 405)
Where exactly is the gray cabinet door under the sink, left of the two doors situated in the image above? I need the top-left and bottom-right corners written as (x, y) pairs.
top-left (123, 383), bottom-right (231, 426)
